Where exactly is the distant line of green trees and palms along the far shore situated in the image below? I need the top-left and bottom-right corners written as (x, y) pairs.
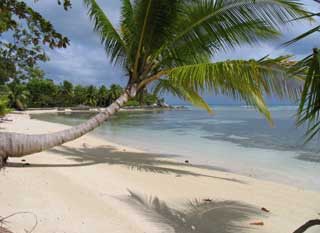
top-left (0, 78), bottom-right (163, 111)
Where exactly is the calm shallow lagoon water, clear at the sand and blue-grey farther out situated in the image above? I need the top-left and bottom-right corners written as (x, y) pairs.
top-left (34, 106), bottom-right (320, 190)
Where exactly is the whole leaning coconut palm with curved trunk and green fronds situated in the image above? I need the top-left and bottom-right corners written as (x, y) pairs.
top-left (0, 0), bottom-right (307, 165)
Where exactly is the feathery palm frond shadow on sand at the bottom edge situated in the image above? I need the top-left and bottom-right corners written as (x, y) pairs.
top-left (126, 190), bottom-right (264, 233)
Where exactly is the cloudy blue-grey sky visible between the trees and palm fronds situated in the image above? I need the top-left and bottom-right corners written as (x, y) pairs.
top-left (25, 0), bottom-right (320, 104)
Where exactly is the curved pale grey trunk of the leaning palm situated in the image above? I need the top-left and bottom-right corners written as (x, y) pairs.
top-left (0, 85), bottom-right (136, 164)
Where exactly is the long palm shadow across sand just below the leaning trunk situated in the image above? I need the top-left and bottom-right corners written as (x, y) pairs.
top-left (8, 146), bottom-right (245, 184)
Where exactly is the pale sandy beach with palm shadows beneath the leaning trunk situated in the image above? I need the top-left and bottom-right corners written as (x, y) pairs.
top-left (0, 114), bottom-right (320, 233)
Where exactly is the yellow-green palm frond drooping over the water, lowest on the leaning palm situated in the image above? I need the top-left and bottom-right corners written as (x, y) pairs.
top-left (166, 58), bottom-right (301, 122)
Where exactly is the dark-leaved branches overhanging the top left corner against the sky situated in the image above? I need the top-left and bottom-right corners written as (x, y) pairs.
top-left (0, 0), bottom-right (70, 84)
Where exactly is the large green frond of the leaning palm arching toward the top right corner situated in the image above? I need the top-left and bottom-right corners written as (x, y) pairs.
top-left (155, 0), bottom-right (309, 61)
